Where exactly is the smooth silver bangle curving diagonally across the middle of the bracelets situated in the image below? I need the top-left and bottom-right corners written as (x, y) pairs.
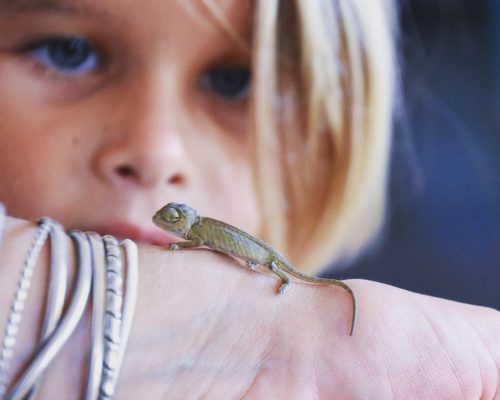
top-left (7, 231), bottom-right (92, 400)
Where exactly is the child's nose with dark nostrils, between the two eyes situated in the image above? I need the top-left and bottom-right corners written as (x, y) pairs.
top-left (95, 70), bottom-right (190, 187)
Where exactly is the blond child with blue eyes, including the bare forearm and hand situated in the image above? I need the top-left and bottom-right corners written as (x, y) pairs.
top-left (0, 0), bottom-right (500, 399)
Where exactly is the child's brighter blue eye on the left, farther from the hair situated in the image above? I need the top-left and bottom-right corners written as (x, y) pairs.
top-left (26, 37), bottom-right (100, 75)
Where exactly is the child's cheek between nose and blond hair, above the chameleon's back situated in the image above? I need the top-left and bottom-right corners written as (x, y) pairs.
top-left (186, 93), bottom-right (261, 236)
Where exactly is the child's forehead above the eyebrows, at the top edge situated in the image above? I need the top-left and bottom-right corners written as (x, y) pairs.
top-left (0, 0), bottom-right (253, 53)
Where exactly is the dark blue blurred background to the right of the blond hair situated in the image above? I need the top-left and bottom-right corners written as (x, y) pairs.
top-left (332, 0), bottom-right (500, 309)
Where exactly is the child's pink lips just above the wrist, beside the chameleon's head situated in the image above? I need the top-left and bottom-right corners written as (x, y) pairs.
top-left (92, 222), bottom-right (179, 246)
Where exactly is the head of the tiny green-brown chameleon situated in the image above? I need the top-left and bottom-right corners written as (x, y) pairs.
top-left (153, 203), bottom-right (198, 239)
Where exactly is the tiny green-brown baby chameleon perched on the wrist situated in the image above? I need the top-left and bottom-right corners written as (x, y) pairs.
top-left (153, 203), bottom-right (357, 335)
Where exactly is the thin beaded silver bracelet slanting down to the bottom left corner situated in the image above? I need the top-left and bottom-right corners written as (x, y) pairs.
top-left (0, 220), bottom-right (51, 399)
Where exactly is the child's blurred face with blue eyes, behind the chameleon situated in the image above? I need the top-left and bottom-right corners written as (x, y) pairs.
top-left (0, 0), bottom-right (259, 242)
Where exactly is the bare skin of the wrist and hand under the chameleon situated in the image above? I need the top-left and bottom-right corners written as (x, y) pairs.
top-left (0, 219), bottom-right (500, 400)
